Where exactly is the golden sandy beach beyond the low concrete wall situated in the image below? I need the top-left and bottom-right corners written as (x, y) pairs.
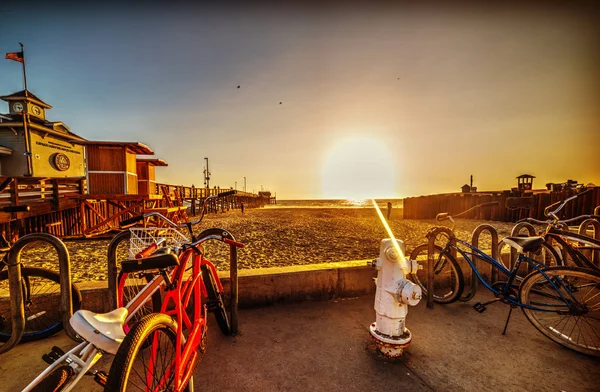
top-left (14, 208), bottom-right (513, 282)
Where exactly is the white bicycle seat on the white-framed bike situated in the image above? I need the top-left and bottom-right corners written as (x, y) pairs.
top-left (70, 308), bottom-right (129, 354)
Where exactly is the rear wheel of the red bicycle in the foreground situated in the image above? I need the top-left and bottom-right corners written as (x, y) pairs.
top-left (104, 313), bottom-right (197, 392)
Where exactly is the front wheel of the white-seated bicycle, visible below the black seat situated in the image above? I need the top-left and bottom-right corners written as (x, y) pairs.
top-left (117, 271), bottom-right (162, 333)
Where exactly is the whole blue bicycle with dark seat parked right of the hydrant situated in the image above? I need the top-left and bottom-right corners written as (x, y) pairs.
top-left (419, 213), bottom-right (600, 356)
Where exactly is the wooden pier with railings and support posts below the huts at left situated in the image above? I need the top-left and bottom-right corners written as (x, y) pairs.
top-left (0, 177), bottom-right (268, 239)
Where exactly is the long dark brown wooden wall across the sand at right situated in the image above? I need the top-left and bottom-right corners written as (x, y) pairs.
top-left (404, 187), bottom-right (600, 222)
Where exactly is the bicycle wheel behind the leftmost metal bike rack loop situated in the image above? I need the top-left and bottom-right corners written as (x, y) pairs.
top-left (0, 267), bottom-right (81, 342)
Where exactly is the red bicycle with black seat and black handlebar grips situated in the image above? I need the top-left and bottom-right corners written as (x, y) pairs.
top-left (105, 207), bottom-right (244, 392)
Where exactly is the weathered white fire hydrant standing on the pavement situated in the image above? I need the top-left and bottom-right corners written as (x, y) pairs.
top-left (370, 238), bottom-right (421, 358)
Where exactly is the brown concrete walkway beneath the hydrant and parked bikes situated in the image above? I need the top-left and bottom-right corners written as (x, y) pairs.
top-left (0, 294), bottom-right (600, 392)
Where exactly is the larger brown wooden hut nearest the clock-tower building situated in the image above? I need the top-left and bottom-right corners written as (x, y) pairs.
top-left (73, 140), bottom-right (154, 195)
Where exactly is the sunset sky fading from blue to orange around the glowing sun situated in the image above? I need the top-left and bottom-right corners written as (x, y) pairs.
top-left (0, 2), bottom-right (600, 199)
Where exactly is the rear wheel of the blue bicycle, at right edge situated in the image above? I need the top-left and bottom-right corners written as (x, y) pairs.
top-left (519, 267), bottom-right (600, 356)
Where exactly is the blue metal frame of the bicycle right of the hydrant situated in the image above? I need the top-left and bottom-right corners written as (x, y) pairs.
top-left (448, 239), bottom-right (571, 312)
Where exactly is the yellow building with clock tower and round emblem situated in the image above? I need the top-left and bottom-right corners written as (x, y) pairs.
top-left (0, 90), bottom-right (85, 178)
